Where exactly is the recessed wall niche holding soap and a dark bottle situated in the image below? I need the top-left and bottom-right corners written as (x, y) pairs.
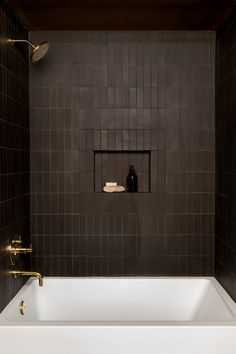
top-left (94, 150), bottom-right (151, 193)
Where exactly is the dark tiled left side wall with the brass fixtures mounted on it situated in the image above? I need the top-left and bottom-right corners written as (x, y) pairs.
top-left (0, 1), bottom-right (30, 311)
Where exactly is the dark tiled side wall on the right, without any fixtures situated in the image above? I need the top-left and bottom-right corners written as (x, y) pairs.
top-left (215, 11), bottom-right (236, 301)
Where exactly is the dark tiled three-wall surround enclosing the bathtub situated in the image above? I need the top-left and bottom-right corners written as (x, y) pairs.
top-left (0, 0), bottom-right (236, 311)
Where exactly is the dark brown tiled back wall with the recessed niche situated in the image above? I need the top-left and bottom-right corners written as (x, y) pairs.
top-left (30, 32), bottom-right (215, 276)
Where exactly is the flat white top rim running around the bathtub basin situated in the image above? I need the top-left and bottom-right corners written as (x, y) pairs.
top-left (0, 276), bottom-right (236, 328)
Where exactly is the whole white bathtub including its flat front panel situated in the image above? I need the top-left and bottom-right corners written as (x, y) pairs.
top-left (0, 278), bottom-right (236, 354)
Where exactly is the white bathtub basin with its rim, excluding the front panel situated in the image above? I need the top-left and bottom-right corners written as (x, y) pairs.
top-left (0, 278), bottom-right (236, 322)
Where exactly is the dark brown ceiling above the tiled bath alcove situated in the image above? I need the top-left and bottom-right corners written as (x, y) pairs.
top-left (10, 0), bottom-right (236, 31)
